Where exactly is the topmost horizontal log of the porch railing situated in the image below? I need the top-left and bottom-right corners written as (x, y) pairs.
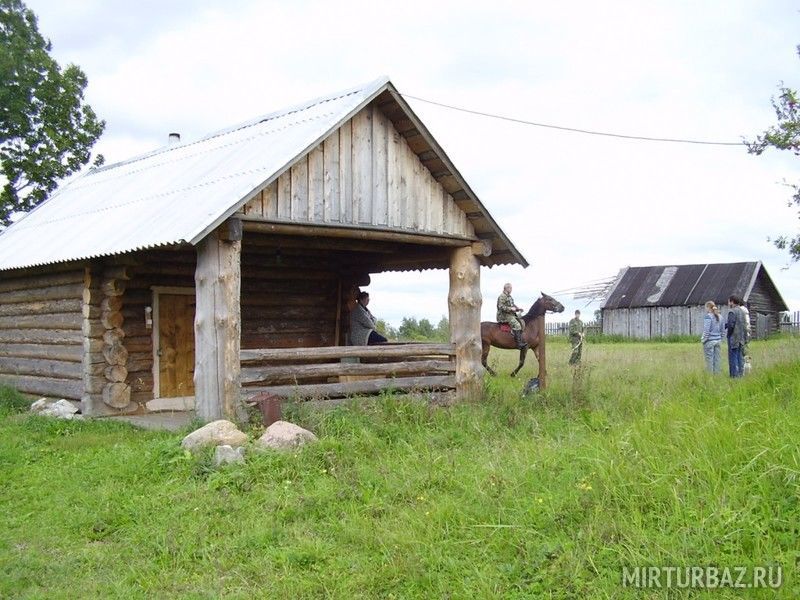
top-left (240, 344), bottom-right (454, 363)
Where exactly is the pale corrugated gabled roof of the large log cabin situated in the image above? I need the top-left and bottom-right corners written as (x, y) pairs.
top-left (0, 78), bottom-right (528, 271)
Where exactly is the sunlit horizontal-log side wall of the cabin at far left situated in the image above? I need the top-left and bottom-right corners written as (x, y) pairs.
top-left (0, 265), bottom-right (85, 400)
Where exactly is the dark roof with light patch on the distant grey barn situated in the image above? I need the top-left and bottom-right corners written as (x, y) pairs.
top-left (603, 261), bottom-right (789, 310)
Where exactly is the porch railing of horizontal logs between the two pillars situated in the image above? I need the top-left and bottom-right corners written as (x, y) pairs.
top-left (240, 344), bottom-right (456, 400)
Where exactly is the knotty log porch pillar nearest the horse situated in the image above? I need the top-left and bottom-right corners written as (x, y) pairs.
top-left (447, 246), bottom-right (484, 400)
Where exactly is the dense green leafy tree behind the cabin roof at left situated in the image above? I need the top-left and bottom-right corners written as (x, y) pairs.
top-left (0, 0), bottom-right (105, 224)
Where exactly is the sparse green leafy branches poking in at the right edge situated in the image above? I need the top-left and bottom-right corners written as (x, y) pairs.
top-left (747, 46), bottom-right (800, 261)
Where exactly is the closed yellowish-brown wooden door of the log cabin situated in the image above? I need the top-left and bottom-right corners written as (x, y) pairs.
top-left (157, 294), bottom-right (195, 398)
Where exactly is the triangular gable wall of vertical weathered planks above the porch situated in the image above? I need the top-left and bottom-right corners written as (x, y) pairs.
top-left (243, 105), bottom-right (475, 237)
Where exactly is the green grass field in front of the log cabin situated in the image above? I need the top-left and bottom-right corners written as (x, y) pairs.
top-left (0, 339), bottom-right (800, 598)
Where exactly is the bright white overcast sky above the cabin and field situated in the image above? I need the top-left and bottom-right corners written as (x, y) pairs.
top-left (27, 0), bottom-right (800, 324)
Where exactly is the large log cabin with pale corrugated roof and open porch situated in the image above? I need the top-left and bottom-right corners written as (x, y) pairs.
top-left (0, 78), bottom-right (527, 420)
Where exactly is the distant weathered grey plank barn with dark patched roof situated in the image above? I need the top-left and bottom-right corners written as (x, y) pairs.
top-left (602, 262), bottom-right (788, 339)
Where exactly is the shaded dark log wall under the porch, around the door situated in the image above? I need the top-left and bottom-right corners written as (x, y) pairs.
top-left (122, 242), bottom-right (339, 403)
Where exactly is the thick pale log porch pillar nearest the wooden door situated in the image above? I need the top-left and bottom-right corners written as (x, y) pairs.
top-left (194, 224), bottom-right (242, 421)
